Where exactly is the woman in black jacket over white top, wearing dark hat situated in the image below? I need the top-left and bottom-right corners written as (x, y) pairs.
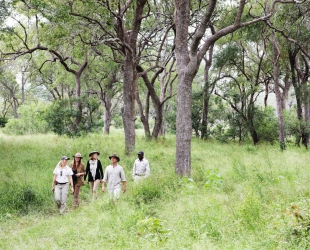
top-left (84, 151), bottom-right (103, 200)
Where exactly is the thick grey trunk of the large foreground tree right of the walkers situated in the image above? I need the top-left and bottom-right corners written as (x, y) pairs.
top-left (175, 0), bottom-right (193, 176)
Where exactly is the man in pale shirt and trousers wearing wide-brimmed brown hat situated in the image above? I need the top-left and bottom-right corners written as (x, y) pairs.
top-left (102, 154), bottom-right (127, 205)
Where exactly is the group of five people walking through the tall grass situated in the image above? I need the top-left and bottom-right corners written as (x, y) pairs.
top-left (52, 151), bottom-right (150, 215)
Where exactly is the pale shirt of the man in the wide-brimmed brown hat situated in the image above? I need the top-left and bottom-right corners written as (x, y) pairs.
top-left (103, 164), bottom-right (126, 189)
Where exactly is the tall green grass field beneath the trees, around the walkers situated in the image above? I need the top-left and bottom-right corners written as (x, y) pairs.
top-left (0, 130), bottom-right (310, 249)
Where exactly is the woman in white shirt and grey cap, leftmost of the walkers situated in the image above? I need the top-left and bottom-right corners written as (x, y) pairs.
top-left (52, 156), bottom-right (74, 215)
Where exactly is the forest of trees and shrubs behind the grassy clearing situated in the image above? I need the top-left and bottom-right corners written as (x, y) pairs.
top-left (0, 0), bottom-right (310, 176)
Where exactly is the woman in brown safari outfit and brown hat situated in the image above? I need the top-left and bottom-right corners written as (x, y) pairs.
top-left (69, 153), bottom-right (85, 208)
